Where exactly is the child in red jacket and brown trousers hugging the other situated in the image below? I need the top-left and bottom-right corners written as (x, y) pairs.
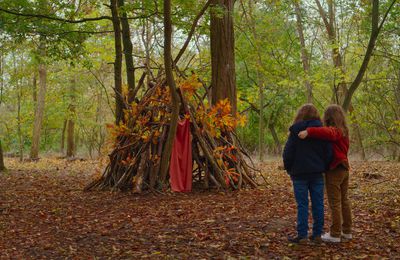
top-left (298, 105), bottom-right (352, 242)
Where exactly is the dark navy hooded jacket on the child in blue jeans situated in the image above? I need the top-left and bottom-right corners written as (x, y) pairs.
top-left (283, 120), bottom-right (333, 179)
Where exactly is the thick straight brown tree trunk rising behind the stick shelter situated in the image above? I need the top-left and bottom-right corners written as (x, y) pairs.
top-left (210, 0), bottom-right (237, 114)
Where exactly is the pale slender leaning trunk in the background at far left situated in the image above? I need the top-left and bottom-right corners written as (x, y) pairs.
top-left (30, 39), bottom-right (47, 160)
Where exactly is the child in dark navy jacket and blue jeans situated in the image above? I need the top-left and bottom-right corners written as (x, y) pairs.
top-left (283, 104), bottom-right (333, 243)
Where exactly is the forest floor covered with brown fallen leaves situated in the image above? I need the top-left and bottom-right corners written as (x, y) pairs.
top-left (0, 159), bottom-right (400, 259)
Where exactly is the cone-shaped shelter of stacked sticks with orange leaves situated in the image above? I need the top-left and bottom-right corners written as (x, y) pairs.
top-left (85, 77), bottom-right (258, 192)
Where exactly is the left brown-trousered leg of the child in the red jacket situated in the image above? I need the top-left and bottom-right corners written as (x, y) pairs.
top-left (325, 168), bottom-right (344, 237)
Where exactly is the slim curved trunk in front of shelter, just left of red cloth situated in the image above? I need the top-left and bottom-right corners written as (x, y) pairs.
top-left (160, 0), bottom-right (179, 185)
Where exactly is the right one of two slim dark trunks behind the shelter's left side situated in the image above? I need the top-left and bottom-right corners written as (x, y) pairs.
top-left (118, 0), bottom-right (135, 103)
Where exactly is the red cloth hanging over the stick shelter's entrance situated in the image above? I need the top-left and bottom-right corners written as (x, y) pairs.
top-left (169, 119), bottom-right (193, 192)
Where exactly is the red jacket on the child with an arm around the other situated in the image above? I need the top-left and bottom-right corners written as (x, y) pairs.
top-left (307, 127), bottom-right (350, 169)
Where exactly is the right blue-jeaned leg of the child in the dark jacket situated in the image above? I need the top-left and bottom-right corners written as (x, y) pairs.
top-left (310, 175), bottom-right (324, 237)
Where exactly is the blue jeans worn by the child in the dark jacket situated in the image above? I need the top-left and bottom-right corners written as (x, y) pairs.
top-left (292, 175), bottom-right (324, 238)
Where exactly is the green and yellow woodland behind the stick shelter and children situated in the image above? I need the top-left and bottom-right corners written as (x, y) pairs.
top-left (0, 0), bottom-right (400, 160)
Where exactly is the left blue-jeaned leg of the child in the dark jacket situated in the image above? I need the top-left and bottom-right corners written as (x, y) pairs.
top-left (293, 180), bottom-right (308, 238)
